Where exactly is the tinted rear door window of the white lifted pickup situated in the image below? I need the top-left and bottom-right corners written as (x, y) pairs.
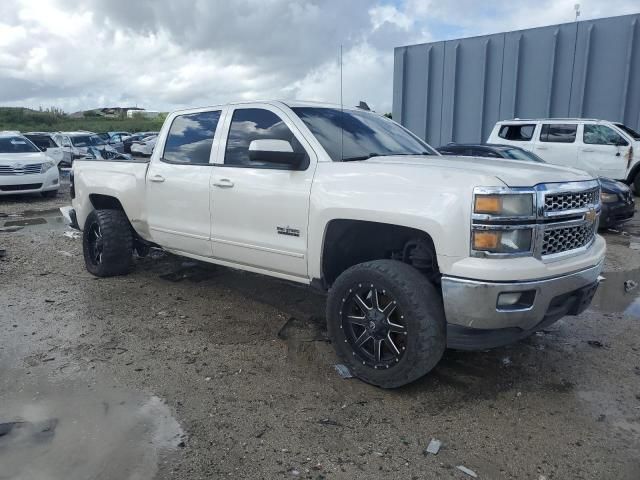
top-left (162, 110), bottom-right (220, 165)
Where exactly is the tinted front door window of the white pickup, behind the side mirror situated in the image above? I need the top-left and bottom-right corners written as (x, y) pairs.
top-left (224, 108), bottom-right (308, 170)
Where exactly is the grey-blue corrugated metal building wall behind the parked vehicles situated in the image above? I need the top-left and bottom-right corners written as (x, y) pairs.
top-left (393, 14), bottom-right (640, 146)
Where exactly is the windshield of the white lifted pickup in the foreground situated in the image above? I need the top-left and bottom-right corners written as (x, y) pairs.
top-left (293, 107), bottom-right (437, 162)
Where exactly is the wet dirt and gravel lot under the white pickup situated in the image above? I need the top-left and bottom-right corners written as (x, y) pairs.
top-left (0, 185), bottom-right (640, 480)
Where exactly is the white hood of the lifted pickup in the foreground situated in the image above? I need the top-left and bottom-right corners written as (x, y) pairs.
top-left (364, 155), bottom-right (595, 187)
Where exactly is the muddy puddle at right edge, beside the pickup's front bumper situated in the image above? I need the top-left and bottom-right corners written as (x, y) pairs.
top-left (591, 269), bottom-right (640, 318)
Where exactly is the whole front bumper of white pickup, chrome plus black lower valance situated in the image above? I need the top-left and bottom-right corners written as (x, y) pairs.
top-left (442, 261), bottom-right (603, 349)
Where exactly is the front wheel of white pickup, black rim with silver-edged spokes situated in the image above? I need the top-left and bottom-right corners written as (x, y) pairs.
top-left (327, 260), bottom-right (446, 388)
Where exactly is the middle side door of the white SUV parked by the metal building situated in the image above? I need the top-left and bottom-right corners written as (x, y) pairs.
top-left (533, 122), bottom-right (581, 168)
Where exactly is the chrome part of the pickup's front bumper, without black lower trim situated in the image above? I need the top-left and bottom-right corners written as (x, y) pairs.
top-left (442, 261), bottom-right (603, 333)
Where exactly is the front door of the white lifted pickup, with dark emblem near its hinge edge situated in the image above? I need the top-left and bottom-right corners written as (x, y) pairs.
top-left (211, 105), bottom-right (316, 278)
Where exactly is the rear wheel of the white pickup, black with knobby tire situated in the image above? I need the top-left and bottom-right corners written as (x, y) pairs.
top-left (82, 210), bottom-right (133, 277)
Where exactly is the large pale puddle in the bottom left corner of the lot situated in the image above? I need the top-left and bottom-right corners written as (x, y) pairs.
top-left (0, 384), bottom-right (184, 480)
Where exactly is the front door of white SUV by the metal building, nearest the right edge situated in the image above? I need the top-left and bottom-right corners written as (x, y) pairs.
top-left (578, 123), bottom-right (630, 180)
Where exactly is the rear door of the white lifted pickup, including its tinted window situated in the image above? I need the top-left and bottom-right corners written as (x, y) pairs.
top-left (146, 109), bottom-right (224, 257)
